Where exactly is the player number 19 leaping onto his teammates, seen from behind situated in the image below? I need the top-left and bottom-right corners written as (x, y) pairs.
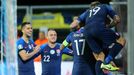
top-left (71, 0), bottom-right (123, 72)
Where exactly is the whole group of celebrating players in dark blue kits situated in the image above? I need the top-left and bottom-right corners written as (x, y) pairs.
top-left (17, 0), bottom-right (125, 75)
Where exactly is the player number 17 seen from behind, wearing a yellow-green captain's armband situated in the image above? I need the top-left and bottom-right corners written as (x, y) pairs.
top-left (60, 27), bottom-right (96, 75)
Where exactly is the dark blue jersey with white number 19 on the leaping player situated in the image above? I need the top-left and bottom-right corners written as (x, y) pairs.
top-left (78, 4), bottom-right (116, 30)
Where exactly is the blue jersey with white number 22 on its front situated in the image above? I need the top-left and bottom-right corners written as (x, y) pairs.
top-left (40, 43), bottom-right (72, 75)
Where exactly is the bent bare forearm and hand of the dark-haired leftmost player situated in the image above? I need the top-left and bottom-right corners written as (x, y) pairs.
top-left (19, 46), bottom-right (40, 61)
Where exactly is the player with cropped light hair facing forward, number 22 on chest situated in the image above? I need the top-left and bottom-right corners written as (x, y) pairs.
top-left (40, 29), bottom-right (73, 75)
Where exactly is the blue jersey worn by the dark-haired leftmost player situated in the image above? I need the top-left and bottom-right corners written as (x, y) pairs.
top-left (17, 38), bottom-right (35, 75)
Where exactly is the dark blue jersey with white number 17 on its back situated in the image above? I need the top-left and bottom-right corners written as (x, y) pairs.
top-left (65, 28), bottom-right (93, 63)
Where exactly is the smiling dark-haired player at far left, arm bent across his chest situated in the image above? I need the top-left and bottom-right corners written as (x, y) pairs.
top-left (17, 22), bottom-right (40, 75)
